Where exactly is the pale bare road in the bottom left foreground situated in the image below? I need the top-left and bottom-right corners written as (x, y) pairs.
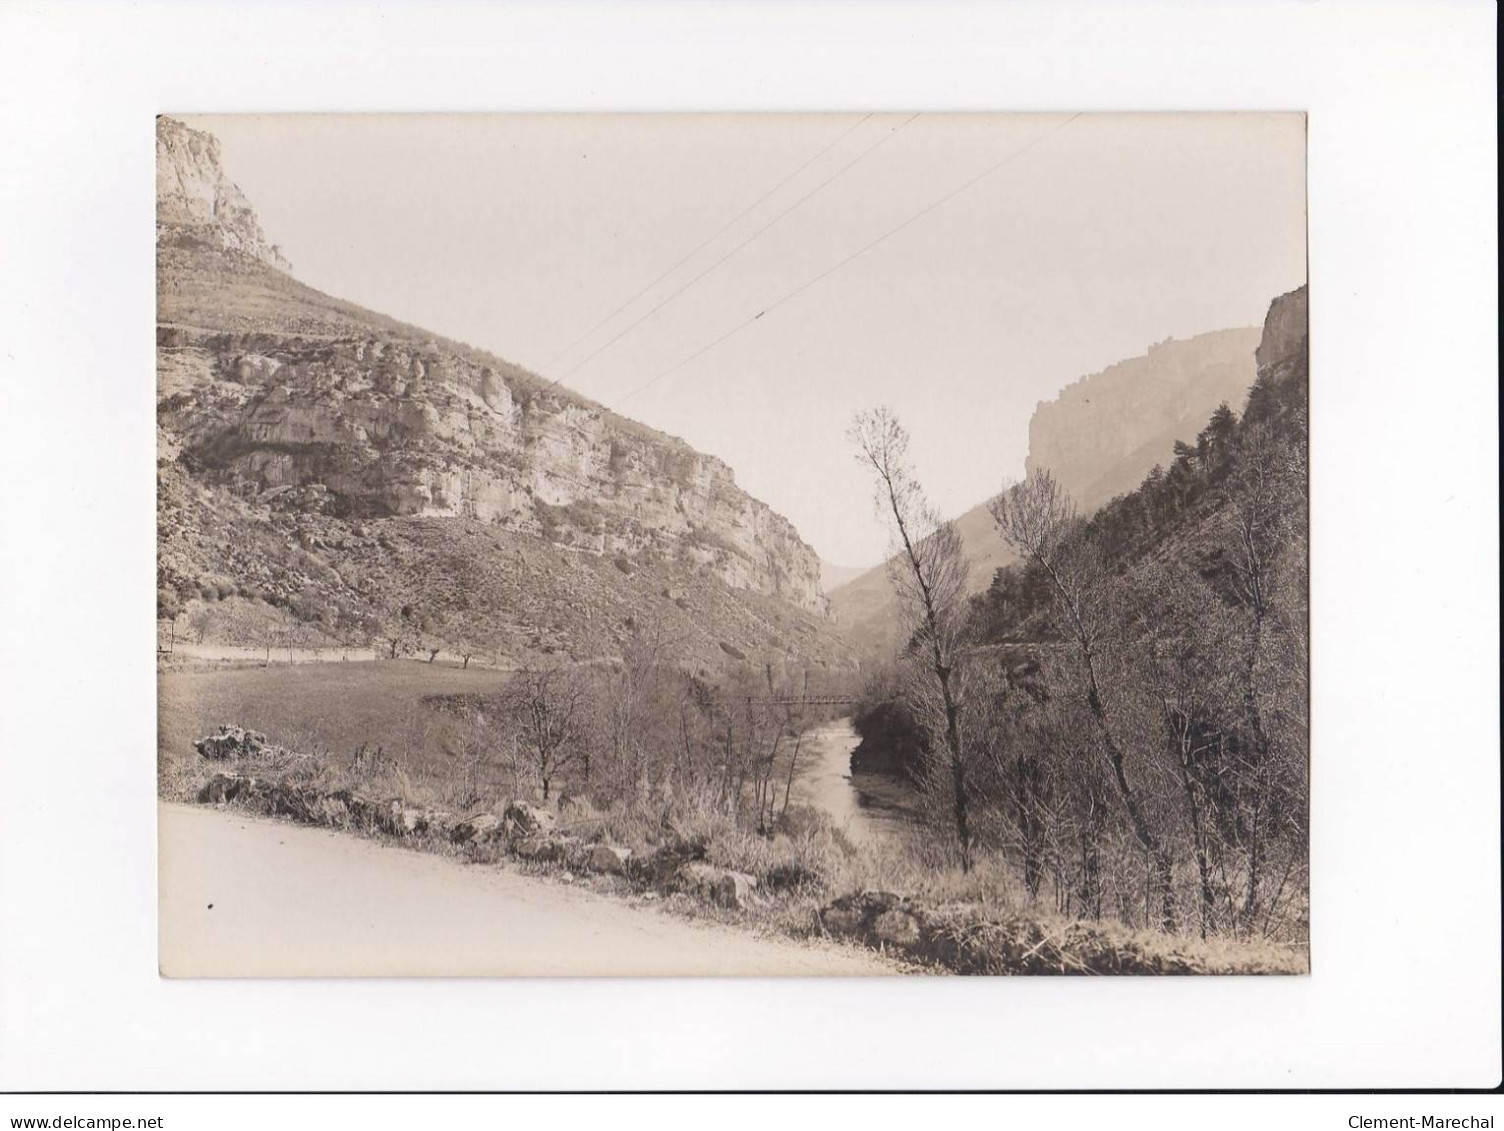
top-left (158, 805), bottom-right (895, 978)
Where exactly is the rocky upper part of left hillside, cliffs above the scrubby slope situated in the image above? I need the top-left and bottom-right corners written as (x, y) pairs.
top-left (158, 119), bottom-right (826, 614)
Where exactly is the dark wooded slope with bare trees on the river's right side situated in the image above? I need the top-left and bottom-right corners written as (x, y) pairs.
top-left (857, 292), bottom-right (1308, 940)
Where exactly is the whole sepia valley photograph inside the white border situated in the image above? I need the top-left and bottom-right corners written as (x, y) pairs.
top-left (149, 111), bottom-right (1305, 978)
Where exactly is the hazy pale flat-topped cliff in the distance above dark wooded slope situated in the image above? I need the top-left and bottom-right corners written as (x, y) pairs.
top-left (1024, 326), bottom-right (1259, 511)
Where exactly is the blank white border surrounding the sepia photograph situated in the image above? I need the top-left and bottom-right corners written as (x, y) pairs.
top-left (0, 3), bottom-right (1501, 1094)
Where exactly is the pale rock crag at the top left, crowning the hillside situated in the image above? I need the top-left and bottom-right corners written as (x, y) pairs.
top-left (156, 116), bottom-right (292, 271)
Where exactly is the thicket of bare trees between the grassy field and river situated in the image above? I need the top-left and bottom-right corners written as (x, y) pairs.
top-left (429, 626), bottom-right (853, 832)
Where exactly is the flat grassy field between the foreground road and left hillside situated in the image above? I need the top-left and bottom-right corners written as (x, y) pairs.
top-left (156, 660), bottom-right (507, 769)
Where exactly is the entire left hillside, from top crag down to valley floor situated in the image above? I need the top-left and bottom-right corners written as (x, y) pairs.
top-left (158, 117), bottom-right (845, 663)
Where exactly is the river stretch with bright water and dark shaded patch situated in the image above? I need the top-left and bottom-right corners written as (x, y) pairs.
top-left (794, 719), bottom-right (916, 844)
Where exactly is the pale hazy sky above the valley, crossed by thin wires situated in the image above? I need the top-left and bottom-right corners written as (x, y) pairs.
top-left (185, 114), bottom-right (1305, 566)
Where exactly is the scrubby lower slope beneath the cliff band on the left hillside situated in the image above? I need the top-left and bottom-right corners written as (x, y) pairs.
top-left (156, 465), bottom-right (851, 671)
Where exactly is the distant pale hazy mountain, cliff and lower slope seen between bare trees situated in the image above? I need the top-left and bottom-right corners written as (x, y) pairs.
top-left (827, 328), bottom-right (1259, 653)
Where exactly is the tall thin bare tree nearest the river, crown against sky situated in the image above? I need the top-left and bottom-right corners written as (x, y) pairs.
top-left (848, 408), bottom-right (973, 871)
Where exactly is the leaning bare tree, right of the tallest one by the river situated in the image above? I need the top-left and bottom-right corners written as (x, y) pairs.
top-left (990, 471), bottom-right (1175, 929)
